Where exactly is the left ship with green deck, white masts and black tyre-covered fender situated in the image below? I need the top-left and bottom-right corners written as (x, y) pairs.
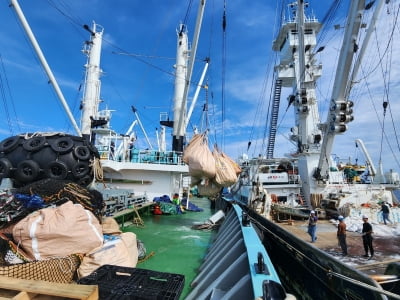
top-left (0, 0), bottom-right (294, 300)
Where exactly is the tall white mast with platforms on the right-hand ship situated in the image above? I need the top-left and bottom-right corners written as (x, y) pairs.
top-left (273, 1), bottom-right (322, 204)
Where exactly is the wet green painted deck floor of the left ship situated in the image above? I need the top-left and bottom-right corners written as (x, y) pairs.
top-left (120, 198), bottom-right (216, 299)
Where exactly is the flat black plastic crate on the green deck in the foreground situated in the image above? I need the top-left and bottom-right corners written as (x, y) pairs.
top-left (78, 265), bottom-right (185, 300)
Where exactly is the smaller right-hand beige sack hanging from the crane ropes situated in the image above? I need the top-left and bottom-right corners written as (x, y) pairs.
top-left (212, 147), bottom-right (237, 187)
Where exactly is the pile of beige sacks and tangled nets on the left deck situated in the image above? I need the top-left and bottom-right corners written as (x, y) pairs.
top-left (0, 178), bottom-right (138, 283)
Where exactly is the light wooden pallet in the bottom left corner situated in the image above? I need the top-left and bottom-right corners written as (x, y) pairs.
top-left (0, 276), bottom-right (99, 300)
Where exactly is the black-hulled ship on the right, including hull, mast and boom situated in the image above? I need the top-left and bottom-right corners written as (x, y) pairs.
top-left (223, 1), bottom-right (399, 299)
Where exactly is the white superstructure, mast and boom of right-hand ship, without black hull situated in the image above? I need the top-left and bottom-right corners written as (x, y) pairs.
top-left (232, 1), bottom-right (399, 222)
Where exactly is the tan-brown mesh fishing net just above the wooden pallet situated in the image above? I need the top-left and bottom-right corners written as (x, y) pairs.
top-left (0, 254), bottom-right (81, 283)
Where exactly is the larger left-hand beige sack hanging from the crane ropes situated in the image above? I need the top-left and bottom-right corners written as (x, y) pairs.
top-left (182, 133), bottom-right (215, 178)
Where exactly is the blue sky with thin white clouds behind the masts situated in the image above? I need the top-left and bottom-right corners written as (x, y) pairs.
top-left (0, 0), bottom-right (400, 170)
